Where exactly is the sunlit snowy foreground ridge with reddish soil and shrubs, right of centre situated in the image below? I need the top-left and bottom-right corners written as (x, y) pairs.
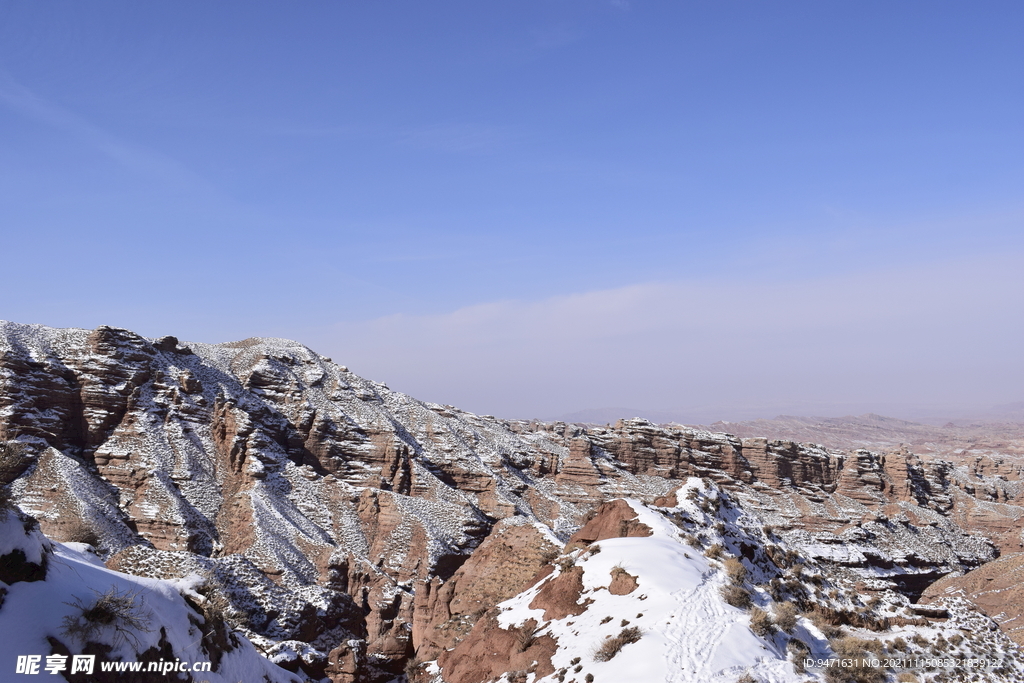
top-left (438, 478), bottom-right (1024, 683)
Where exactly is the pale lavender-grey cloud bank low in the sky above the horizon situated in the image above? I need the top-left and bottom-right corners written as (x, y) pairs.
top-left (314, 254), bottom-right (1024, 419)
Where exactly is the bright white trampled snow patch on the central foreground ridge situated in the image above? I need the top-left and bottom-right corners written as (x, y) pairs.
top-left (499, 480), bottom-right (805, 683)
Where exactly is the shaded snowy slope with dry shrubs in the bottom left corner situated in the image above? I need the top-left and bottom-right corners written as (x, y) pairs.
top-left (0, 509), bottom-right (302, 683)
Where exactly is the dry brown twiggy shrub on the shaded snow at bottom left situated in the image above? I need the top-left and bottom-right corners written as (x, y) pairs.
top-left (61, 587), bottom-right (153, 649)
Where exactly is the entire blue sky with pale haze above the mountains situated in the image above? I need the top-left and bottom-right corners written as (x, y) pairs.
top-left (0, 0), bottom-right (1024, 419)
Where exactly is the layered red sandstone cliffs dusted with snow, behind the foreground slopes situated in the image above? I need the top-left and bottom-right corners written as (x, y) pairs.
top-left (0, 323), bottom-right (1021, 681)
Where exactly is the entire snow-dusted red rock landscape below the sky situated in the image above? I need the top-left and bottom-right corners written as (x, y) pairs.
top-left (0, 322), bottom-right (1024, 683)
